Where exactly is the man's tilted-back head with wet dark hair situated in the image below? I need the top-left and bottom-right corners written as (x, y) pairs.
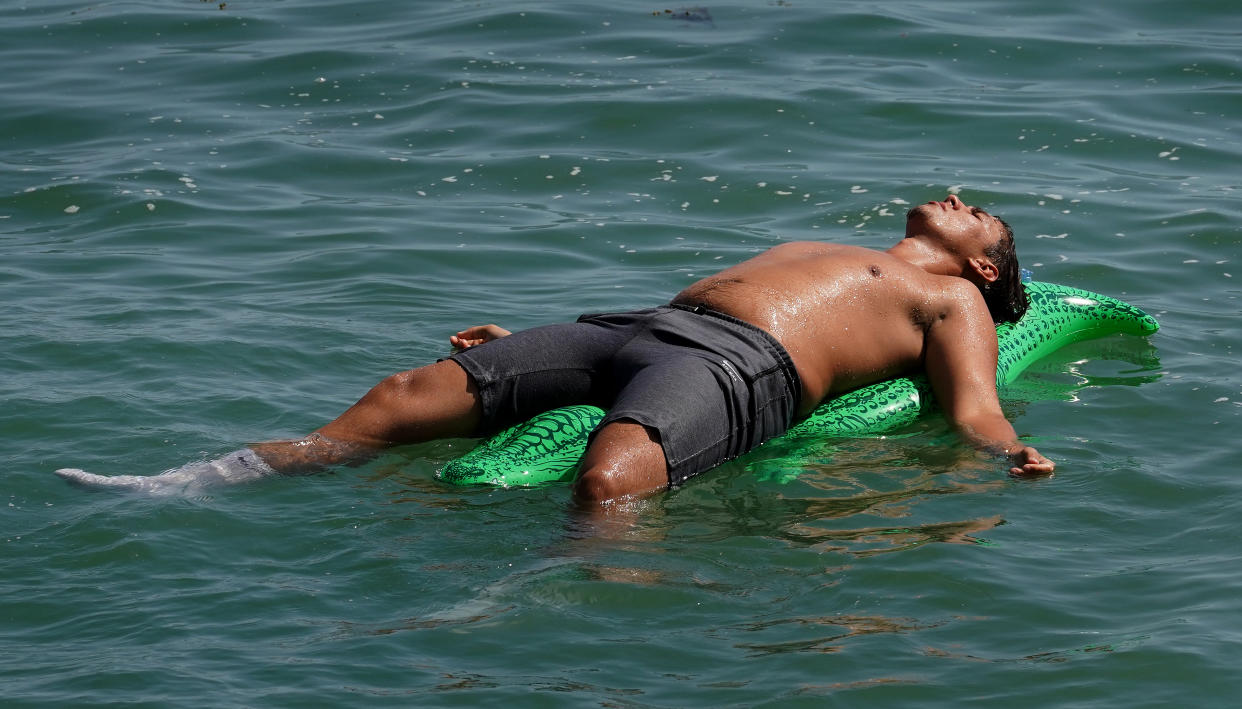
top-left (905, 195), bottom-right (1027, 323)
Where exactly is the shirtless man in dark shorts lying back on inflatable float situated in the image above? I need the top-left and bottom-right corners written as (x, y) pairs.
top-left (57, 195), bottom-right (1054, 503)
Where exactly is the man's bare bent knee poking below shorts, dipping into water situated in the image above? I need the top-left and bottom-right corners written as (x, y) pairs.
top-left (574, 420), bottom-right (668, 504)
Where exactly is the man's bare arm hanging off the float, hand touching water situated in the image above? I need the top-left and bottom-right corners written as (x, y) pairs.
top-left (924, 282), bottom-right (1056, 476)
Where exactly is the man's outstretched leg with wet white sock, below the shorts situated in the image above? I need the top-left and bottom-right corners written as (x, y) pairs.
top-left (56, 361), bottom-right (482, 493)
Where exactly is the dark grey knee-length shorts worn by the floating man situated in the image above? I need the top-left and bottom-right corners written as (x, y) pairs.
top-left (450, 305), bottom-right (802, 484)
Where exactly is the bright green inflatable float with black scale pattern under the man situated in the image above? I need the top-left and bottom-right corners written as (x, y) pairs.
top-left (440, 282), bottom-right (1160, 487)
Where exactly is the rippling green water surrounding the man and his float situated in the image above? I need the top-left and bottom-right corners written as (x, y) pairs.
top-left (0, 0), bottom-right (1242, 708)
